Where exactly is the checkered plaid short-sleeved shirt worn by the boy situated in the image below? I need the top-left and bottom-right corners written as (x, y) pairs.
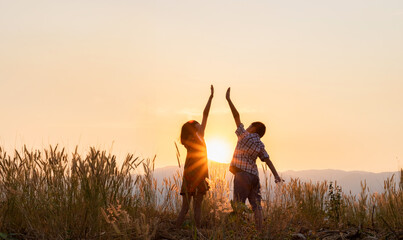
top-left (230, 123), bottom-right (270, 176)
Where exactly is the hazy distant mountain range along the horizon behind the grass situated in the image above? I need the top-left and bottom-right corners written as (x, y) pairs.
top-left (154, 166), bottom-right (400, 195)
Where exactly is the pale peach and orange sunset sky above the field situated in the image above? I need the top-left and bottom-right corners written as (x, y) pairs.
top-left (0, 0), bottom-right (403, 172)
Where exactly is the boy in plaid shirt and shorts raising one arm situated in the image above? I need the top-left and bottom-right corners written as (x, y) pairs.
top-left (226, 88), bottom-right (283, 230)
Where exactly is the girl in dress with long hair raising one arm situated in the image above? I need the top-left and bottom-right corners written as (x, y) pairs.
top-left (176, 85), bottom-right (214, 227)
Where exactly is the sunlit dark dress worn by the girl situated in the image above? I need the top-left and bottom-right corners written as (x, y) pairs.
top-left (180, 135), bottom-right (210, 196)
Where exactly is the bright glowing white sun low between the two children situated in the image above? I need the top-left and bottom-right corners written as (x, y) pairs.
top-left (206, 138), bottom-right (232, 163)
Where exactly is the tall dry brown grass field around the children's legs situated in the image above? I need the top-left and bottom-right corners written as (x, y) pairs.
top-left (0, 147), bottom-right (403, 239)
